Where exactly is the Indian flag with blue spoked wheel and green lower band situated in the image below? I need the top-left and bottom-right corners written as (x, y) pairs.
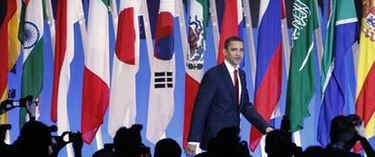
top-left (20, 0), bottom-right (44, 125)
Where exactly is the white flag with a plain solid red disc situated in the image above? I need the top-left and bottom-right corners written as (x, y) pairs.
top-left (108, 0), bottom-right (140, 137)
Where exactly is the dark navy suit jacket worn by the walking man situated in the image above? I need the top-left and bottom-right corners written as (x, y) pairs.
top-left (188, 63), bottom-right (269, 150)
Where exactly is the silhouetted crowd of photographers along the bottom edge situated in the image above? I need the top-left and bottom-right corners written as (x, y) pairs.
top-left (0, 115), bottom-right (375, 157)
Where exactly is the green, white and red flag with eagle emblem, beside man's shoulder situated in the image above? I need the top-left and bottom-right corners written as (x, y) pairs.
top-left (183, 0), bottom-right (209, 147)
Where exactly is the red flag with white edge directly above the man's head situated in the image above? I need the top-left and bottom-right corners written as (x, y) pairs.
top-left (217, 0), bottom-right (243, 64)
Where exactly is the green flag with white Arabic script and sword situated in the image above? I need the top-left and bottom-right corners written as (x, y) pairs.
top-left (286, 0), bottom-right (318, 132)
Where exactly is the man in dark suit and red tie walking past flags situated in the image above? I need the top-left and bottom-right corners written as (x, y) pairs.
top-left (186, 37), bottom-right (273, 155)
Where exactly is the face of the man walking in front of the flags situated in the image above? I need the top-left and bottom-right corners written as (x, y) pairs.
top-left (224, 41), bottom-right (243, 66)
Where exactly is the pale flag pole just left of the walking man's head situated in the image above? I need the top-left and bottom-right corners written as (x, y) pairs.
top-left (210, 0), bottom-right (220, 60)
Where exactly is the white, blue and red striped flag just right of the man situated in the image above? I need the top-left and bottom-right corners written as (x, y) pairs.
top-left (249, 0), bottom-right (282, 151)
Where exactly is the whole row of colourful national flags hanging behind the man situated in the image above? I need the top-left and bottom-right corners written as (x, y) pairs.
top-left (0, 0), bottom-right (375, 155)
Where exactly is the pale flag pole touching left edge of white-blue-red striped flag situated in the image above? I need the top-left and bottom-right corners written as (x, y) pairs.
top-left (243, 0), bottom-right (257, 85)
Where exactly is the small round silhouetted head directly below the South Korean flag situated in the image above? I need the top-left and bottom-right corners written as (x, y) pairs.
top-left (154, 138), bottom-right (181, 157)
